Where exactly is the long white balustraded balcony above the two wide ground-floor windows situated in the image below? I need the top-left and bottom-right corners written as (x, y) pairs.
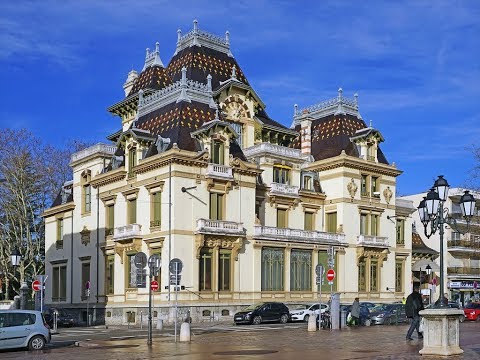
top-left (253, 225), bottom-right (346, 246)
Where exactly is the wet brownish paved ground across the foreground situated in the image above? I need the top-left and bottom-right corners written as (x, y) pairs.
top-left (0, 322), bottom-right (480, 360)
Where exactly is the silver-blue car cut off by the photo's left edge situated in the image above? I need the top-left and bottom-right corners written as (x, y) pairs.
top-left (0, 310), bottom-right (51, 350)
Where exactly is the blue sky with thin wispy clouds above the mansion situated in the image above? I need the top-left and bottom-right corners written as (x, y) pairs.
top-left (0, 0), bottom-right (480, 195)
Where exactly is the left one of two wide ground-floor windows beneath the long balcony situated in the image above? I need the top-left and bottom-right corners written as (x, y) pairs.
top-left (262, 248), bottom-right (285, 291)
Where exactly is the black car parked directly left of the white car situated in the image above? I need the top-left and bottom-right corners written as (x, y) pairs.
top-left (233, 302), bottom-right (290, 325)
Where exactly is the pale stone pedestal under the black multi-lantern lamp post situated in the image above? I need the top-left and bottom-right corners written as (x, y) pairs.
top-left (419, 308), bottom-right (463, 356)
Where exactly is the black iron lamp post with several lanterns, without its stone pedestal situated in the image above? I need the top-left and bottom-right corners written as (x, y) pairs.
top-left (418, 175), bottom-right (475, 307)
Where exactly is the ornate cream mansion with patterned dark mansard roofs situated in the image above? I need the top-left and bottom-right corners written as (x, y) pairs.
top-left (44, 22), bottom-right (414, 324)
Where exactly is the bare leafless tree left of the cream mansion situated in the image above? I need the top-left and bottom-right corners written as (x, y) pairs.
top-left (0, 129), bottom-right (79, 299)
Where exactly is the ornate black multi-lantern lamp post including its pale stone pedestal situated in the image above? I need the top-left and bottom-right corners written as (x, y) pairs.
top-left (418, 175), bottom-right (475, 356)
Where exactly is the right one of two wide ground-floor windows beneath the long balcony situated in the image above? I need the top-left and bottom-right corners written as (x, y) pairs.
top-left (290, 249), bottom-right (312, 291)
